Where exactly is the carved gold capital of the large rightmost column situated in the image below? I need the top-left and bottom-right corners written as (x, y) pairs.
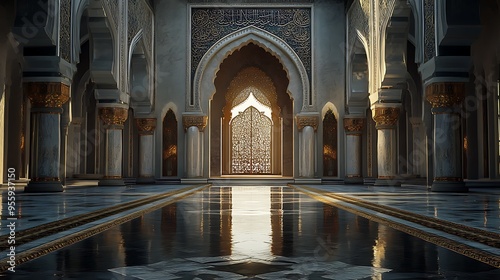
top-left (425, 82), bottom-right (465, 108)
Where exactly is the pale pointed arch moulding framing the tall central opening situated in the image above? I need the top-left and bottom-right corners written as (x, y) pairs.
top-left (190, 26), bottom-right (308, 112)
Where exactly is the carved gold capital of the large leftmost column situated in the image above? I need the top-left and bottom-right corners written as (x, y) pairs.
top-left (23, 82), bottom-right (69, 108)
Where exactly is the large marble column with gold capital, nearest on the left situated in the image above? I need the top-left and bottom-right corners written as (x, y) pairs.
top-left (24, 82), bottom-right (70, 192)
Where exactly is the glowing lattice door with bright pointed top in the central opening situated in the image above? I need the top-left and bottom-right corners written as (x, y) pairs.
top-left (230, 92), bottom-right (273, 174)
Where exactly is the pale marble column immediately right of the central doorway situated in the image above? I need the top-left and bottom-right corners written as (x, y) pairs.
top-left (296, 115), bottom-right (318, 178)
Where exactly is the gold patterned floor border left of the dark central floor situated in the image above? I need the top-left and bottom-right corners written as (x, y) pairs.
top-left (0, 184), bottom-right (210, 272)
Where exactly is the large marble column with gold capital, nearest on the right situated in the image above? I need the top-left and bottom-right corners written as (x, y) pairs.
top-left (425, 82), bottom-right (468, 192)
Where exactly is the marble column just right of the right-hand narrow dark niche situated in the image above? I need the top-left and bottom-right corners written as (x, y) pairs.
top-left (344, 118), bottom-right (365, 184)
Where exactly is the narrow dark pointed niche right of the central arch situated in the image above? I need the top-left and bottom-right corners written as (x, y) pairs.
top-left (323, 109), bottom-right (338, 177)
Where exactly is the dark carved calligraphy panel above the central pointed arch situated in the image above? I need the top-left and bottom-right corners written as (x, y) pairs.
top-left (191, 7), bottom-right (312, 79)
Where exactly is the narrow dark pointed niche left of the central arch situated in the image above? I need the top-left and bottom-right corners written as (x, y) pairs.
top-left (162, 109), bottom-right (177, 177)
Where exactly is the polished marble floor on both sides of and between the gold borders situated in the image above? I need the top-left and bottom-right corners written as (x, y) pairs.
top-left (2, 186), bottom-right (500, 279)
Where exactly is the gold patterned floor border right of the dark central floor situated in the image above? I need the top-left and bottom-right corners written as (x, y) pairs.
top-left (289, 184), bottom-right (500, 268)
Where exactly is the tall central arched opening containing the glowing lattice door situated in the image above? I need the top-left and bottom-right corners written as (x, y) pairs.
top-left (209, 43), bottom-right (293, 177)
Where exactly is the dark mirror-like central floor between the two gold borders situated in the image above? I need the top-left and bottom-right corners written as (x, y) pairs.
top-left (4, 187), bottom-right (500, 279)
